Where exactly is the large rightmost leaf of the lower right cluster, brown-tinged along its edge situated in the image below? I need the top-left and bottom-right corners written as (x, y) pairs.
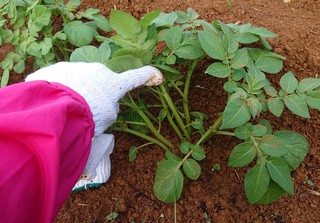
top-left (273, 131), bottom-right (309, 170)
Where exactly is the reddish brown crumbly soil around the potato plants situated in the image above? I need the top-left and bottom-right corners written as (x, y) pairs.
top-left (6, 0), bottom-right (320, 223)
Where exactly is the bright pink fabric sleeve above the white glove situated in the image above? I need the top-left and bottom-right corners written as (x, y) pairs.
top-left (0, 81), bottom-right (94, 223)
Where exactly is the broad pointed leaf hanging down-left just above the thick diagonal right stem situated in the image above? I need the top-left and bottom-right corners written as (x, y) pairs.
top-left (220, 98), bottom-right (251, 129)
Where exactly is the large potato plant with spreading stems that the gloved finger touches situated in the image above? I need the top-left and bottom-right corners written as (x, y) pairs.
top-left (98, 8), bottom-right (320, 204)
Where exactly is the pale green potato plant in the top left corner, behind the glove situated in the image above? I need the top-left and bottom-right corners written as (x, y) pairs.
top-left (0, 0), bottom-right (111, 87)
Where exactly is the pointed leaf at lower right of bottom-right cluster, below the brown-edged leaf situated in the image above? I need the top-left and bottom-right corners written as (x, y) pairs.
top-left (267, 157), bottom-right (294, 195)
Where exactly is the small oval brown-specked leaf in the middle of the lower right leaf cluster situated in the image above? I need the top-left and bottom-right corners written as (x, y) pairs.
top-left (259, 135), bottom-right (287, 156)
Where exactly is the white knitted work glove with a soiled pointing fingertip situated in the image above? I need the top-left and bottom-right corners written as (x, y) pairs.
top-left (26, 62), bottom-right (163, 190)
